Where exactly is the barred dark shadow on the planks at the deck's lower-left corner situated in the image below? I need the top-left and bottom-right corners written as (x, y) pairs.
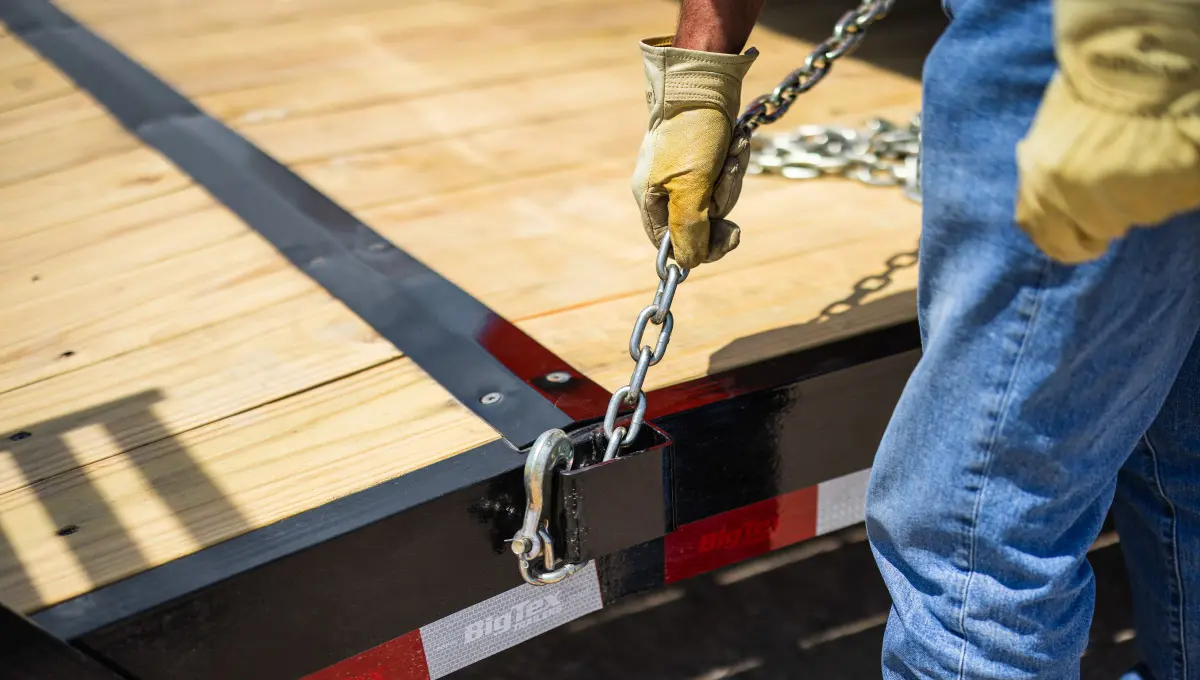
top-left (0, 390), bottom-right (250, 614)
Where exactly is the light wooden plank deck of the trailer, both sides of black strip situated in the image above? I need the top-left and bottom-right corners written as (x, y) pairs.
top-left (0, 0), bottom-right (940, 612)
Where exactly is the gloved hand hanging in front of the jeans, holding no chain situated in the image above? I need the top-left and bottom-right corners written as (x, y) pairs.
top-left (1016, 0), bottom-right (1200, 263)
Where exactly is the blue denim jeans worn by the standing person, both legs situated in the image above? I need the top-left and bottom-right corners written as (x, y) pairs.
top-left (866, 0), bottom-right (1200, 680)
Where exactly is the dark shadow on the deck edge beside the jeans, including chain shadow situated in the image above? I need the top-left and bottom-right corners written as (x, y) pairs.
top-left (708, 249), bottom-right (917, 374)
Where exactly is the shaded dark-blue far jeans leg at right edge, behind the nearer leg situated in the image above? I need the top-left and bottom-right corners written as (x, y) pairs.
top-left (1112, 338), bottom-right (1200, 680)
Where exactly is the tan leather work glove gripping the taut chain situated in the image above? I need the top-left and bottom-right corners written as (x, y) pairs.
top-left (631, 36), bottom-right (758, 269)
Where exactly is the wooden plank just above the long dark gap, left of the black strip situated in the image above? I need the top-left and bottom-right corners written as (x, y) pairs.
top-left (0, 287), bottom-right (397, 494)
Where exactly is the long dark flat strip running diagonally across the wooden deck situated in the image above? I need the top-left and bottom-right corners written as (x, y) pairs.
top-left (0, 0), bottom-right (572, 447)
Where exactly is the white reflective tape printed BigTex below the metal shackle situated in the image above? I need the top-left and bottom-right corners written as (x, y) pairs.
top-left (421, 562), bottom-right (604, 680)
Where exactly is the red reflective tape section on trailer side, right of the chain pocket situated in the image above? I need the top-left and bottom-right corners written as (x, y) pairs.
top-left (662, 487), bottom-right (818, 583)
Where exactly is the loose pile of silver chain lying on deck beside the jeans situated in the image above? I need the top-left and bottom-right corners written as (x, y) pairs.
top-left (746, 114), bottom-right (920, 203)
